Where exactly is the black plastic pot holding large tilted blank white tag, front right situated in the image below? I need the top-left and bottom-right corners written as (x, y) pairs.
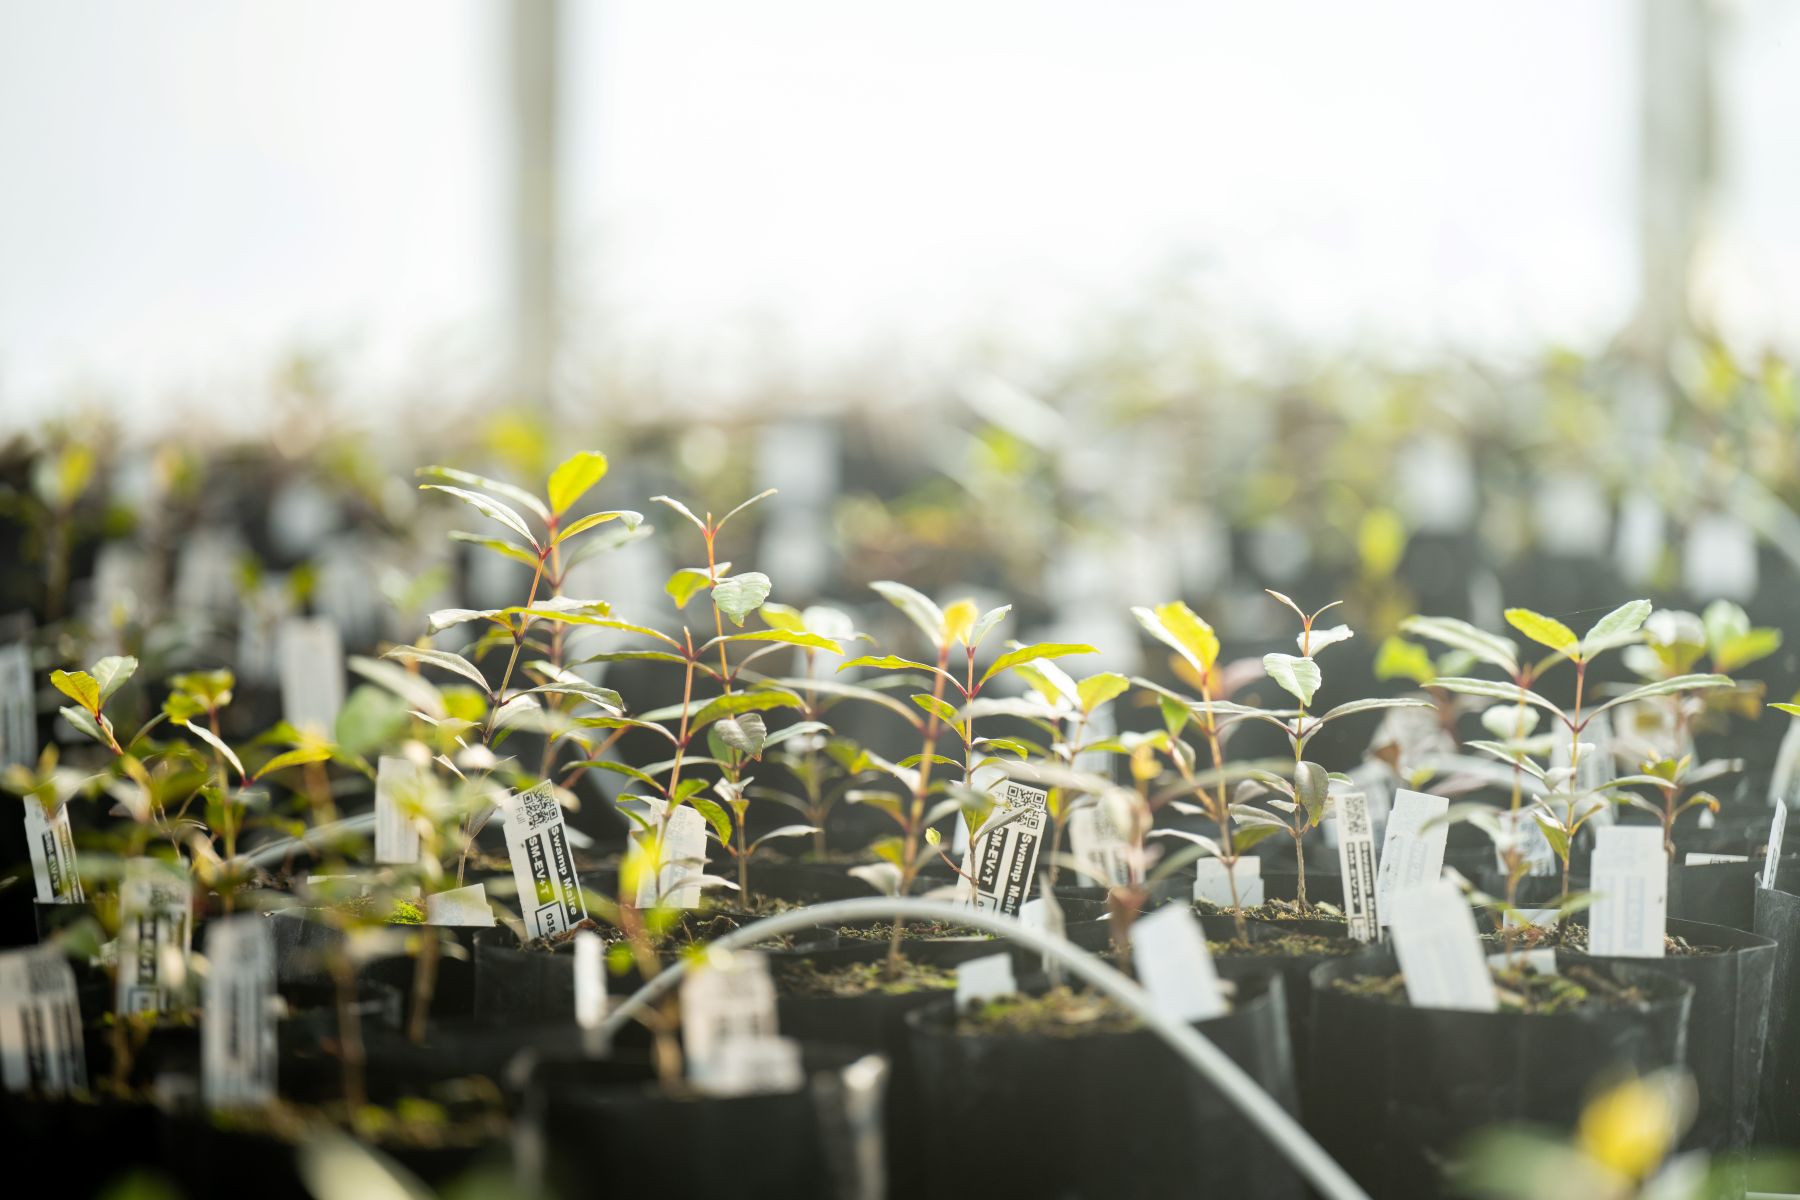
top-left (1309, 954), bottom-right (1694, 1196)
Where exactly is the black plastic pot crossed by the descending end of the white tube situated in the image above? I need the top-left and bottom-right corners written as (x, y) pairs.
top-left (907, 973), bottom-right (1303, 1200)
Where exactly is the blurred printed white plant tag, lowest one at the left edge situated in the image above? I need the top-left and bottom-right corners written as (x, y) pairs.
top-left (0, 946), bottom-right (88, 1096)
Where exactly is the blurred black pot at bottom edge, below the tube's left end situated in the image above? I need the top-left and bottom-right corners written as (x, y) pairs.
top-left (518, 1047), bottom-right (880, 1200)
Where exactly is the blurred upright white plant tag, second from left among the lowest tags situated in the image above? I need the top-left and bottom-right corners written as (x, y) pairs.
top-left (200, 914), bottom-right (275, 1108)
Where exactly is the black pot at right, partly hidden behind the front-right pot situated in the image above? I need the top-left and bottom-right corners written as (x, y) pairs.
top-left (1564, 919), bottom-right (1775, 1151)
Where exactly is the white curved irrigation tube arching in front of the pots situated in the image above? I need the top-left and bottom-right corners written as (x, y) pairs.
top-left (596, 896), bottom-right (1370, 1200)
